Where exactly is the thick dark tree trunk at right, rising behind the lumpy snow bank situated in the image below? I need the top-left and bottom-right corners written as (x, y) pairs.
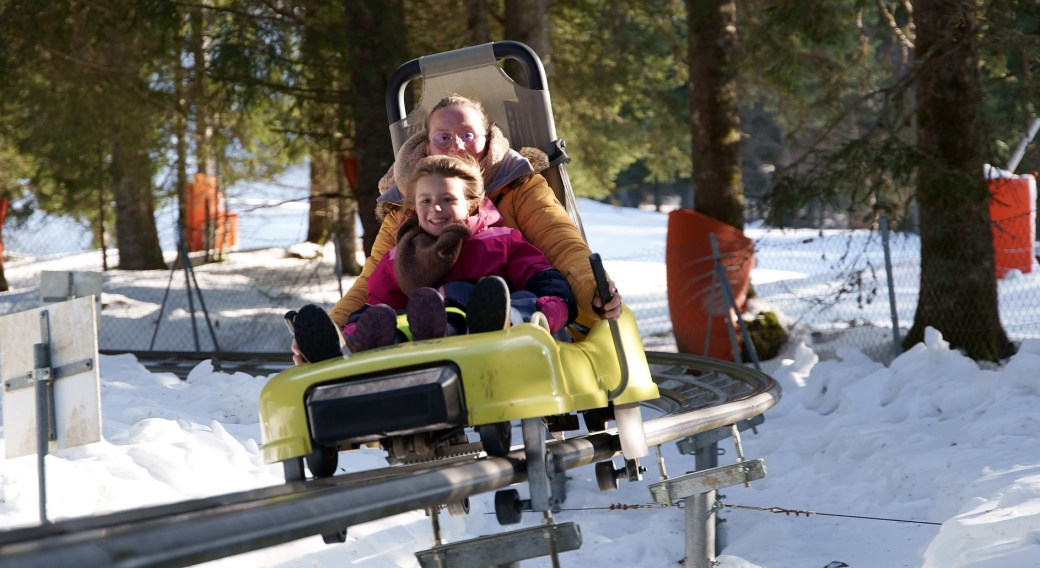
top-left (903, 0), bottom-right (1013, 361)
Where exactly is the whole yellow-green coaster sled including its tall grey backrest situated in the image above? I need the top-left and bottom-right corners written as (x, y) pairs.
top-left (260, 42), bottom-right (658, 522)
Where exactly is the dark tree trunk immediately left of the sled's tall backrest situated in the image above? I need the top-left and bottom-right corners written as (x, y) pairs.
top-left (343, 0), bottom-right (408, 255)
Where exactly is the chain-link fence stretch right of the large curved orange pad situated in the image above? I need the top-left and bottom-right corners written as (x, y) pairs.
top-left (749, 209), bottom-right (1040, 361)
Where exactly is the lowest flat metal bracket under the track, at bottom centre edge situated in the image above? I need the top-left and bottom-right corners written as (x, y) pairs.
top-left (415, 522), bottom-right (581, 568)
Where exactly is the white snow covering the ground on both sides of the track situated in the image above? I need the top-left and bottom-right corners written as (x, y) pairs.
top-left (0, 202), bottom-right (1040, 568)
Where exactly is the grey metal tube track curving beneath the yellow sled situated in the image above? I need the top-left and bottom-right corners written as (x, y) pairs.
top-left (0, 352), bottom-right (780, 568)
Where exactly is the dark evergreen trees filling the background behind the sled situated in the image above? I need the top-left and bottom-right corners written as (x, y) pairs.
top-left (0, 0), bottom-right (1040, 359)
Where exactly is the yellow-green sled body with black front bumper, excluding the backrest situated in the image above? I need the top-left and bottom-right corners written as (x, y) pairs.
top-left (260, 308), bottom-right (658, 466)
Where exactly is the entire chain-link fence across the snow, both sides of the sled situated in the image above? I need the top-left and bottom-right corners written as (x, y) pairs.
top-left (0, 208), bottom-right (1040, 361)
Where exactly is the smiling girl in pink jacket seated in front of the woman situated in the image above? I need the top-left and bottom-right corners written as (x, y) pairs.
top-left (343, 156), bottom-right (577, 351)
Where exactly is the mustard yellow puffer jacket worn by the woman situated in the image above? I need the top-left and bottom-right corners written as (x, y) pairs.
top-left (330, 174), bottom-right (601, 327)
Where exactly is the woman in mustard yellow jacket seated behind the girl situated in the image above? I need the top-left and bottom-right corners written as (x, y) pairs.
top-left (292, 96), bottom-right (621, 363)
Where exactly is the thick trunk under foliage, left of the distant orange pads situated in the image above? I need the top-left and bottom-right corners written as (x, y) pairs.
top-left (111, 141), bottom-right (166, 270)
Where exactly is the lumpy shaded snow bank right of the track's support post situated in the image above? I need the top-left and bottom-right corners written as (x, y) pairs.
top-left (726, 329), bottom-right (1040, 568)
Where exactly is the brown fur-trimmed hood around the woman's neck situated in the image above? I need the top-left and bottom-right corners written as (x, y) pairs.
top-left (375, 125), bottom-right (549, 222)
